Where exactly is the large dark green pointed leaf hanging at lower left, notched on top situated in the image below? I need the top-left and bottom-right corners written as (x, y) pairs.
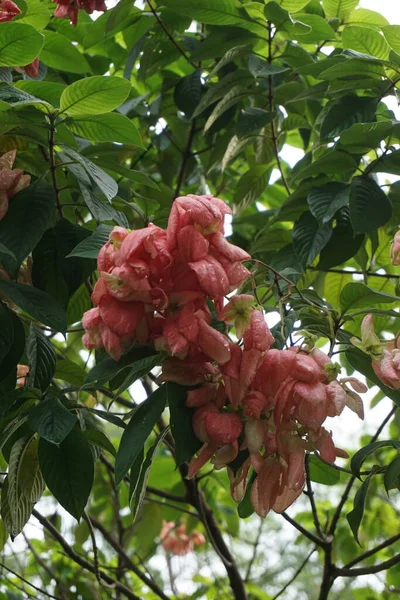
top-left (39, 427), bottom-right (94, 520)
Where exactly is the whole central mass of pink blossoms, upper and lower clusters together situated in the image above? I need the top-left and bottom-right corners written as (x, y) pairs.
top-left (83, 195), bottom-right (366, 516)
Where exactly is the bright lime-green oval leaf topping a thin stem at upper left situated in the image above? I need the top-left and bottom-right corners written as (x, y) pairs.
top-left (60, 75), bottom-right (131, 115)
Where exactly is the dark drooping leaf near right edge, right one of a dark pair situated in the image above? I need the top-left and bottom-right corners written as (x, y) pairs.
top-left (350, 177), bottom-right (392, 233)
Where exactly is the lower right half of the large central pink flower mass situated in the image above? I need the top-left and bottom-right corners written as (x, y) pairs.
top-left (187, 312), bottom-right (366, 517)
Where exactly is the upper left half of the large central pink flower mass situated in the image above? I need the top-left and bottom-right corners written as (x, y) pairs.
top-left (82, 196), bottom-right (250, 364)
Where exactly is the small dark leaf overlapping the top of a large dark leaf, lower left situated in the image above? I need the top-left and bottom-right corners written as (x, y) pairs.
top-left (28, 397), bottom-right (78, 445)
